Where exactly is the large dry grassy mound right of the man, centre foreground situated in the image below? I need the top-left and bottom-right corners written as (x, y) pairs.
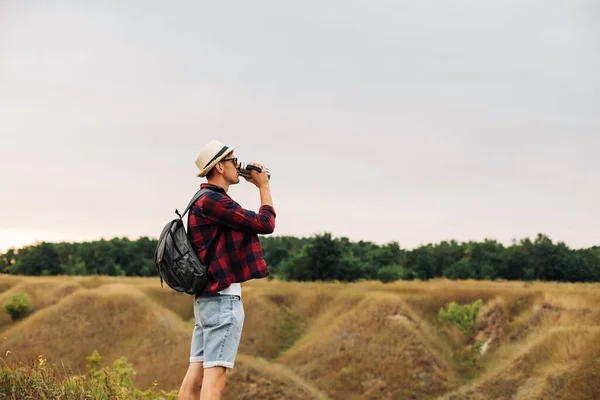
top-left (281, 293), bottom-right (457, 399)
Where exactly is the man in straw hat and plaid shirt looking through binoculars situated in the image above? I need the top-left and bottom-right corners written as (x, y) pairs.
top-left (178, 140), bottom-right (276, 400)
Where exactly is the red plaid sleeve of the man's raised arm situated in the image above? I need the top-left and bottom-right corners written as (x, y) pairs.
top-left (202, 192), bottom-right (276, 234)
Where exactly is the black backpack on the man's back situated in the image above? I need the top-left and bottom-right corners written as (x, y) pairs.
top-left (154, 188), bottom-right (210, 295)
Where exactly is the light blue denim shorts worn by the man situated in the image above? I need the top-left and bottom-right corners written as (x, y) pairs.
top-left (190, 294), bottom-right (245, 368)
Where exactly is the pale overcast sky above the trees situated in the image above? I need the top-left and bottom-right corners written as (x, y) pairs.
top-left (0, 0), bottom-right (600, 251)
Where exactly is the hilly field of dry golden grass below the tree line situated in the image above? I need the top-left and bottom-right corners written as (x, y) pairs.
top-left (0, 276), bottom-right (600, 400)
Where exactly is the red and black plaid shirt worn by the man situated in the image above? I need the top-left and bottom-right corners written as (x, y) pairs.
top-left (188, 183), bottom-right (275, 293)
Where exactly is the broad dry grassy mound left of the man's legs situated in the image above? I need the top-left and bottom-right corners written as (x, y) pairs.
top-left (0, 284), bottom-right (191, 387)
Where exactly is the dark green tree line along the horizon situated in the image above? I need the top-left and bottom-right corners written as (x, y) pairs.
top-left (0, 233), bottom-right (600, 282)
